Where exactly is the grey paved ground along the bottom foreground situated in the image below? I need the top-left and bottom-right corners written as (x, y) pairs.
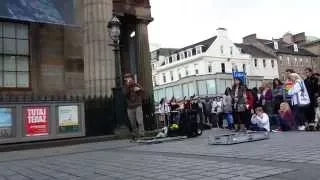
top-left (0, 151), bottom-right (292, 180)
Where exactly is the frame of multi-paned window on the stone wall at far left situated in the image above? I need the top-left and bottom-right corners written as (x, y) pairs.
top-left (0, 20), bottom-right (32, 91)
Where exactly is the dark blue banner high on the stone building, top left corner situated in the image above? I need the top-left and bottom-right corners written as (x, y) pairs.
top-left (0, 0), bottom-right (75, 26)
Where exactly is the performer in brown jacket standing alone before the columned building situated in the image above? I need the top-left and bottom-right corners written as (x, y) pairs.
top-left (124, 73), bottom-right (144, 138)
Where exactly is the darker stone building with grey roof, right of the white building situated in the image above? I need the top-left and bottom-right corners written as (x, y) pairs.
top-left (243, 34), bottom-right (317, 80)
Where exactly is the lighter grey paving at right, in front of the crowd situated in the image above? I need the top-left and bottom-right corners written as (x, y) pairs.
top-left (128, 131), bottom-right (320, 164)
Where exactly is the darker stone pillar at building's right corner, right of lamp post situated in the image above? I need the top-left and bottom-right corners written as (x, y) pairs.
top-left (135, 21), bottom-right (153, 98)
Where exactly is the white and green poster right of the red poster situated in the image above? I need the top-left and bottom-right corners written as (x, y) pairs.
top-left (58, 106), bottom-right (80, 133)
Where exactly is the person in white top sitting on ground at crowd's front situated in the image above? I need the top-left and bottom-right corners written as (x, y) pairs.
top-left (251, 106), bottom-right (270, 132)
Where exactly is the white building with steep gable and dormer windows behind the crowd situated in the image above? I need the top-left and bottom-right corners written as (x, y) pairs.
top-left (153, 28), bottom-right (278, 101)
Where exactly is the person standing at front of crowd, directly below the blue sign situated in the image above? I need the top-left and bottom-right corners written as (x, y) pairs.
top-left (231, 78), bottom-right (246, 131)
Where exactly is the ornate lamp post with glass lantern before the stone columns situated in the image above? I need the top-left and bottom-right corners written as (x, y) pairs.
top-left (108, 16), bottom-right (125, 129)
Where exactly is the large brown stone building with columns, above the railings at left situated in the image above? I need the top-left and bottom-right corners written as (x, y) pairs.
top-left (0, 0), bottom-right (152, 100)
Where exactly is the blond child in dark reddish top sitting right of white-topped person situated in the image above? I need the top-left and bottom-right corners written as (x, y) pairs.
top-left (279, 102), bottom-right (296, 131)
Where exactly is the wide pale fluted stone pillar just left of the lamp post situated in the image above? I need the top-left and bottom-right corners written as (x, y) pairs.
top-left (83, 0), bottom-right (115, 96)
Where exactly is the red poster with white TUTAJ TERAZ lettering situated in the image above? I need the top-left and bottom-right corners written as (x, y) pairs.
top-left (24, 107), bottom-right (49, 136)
